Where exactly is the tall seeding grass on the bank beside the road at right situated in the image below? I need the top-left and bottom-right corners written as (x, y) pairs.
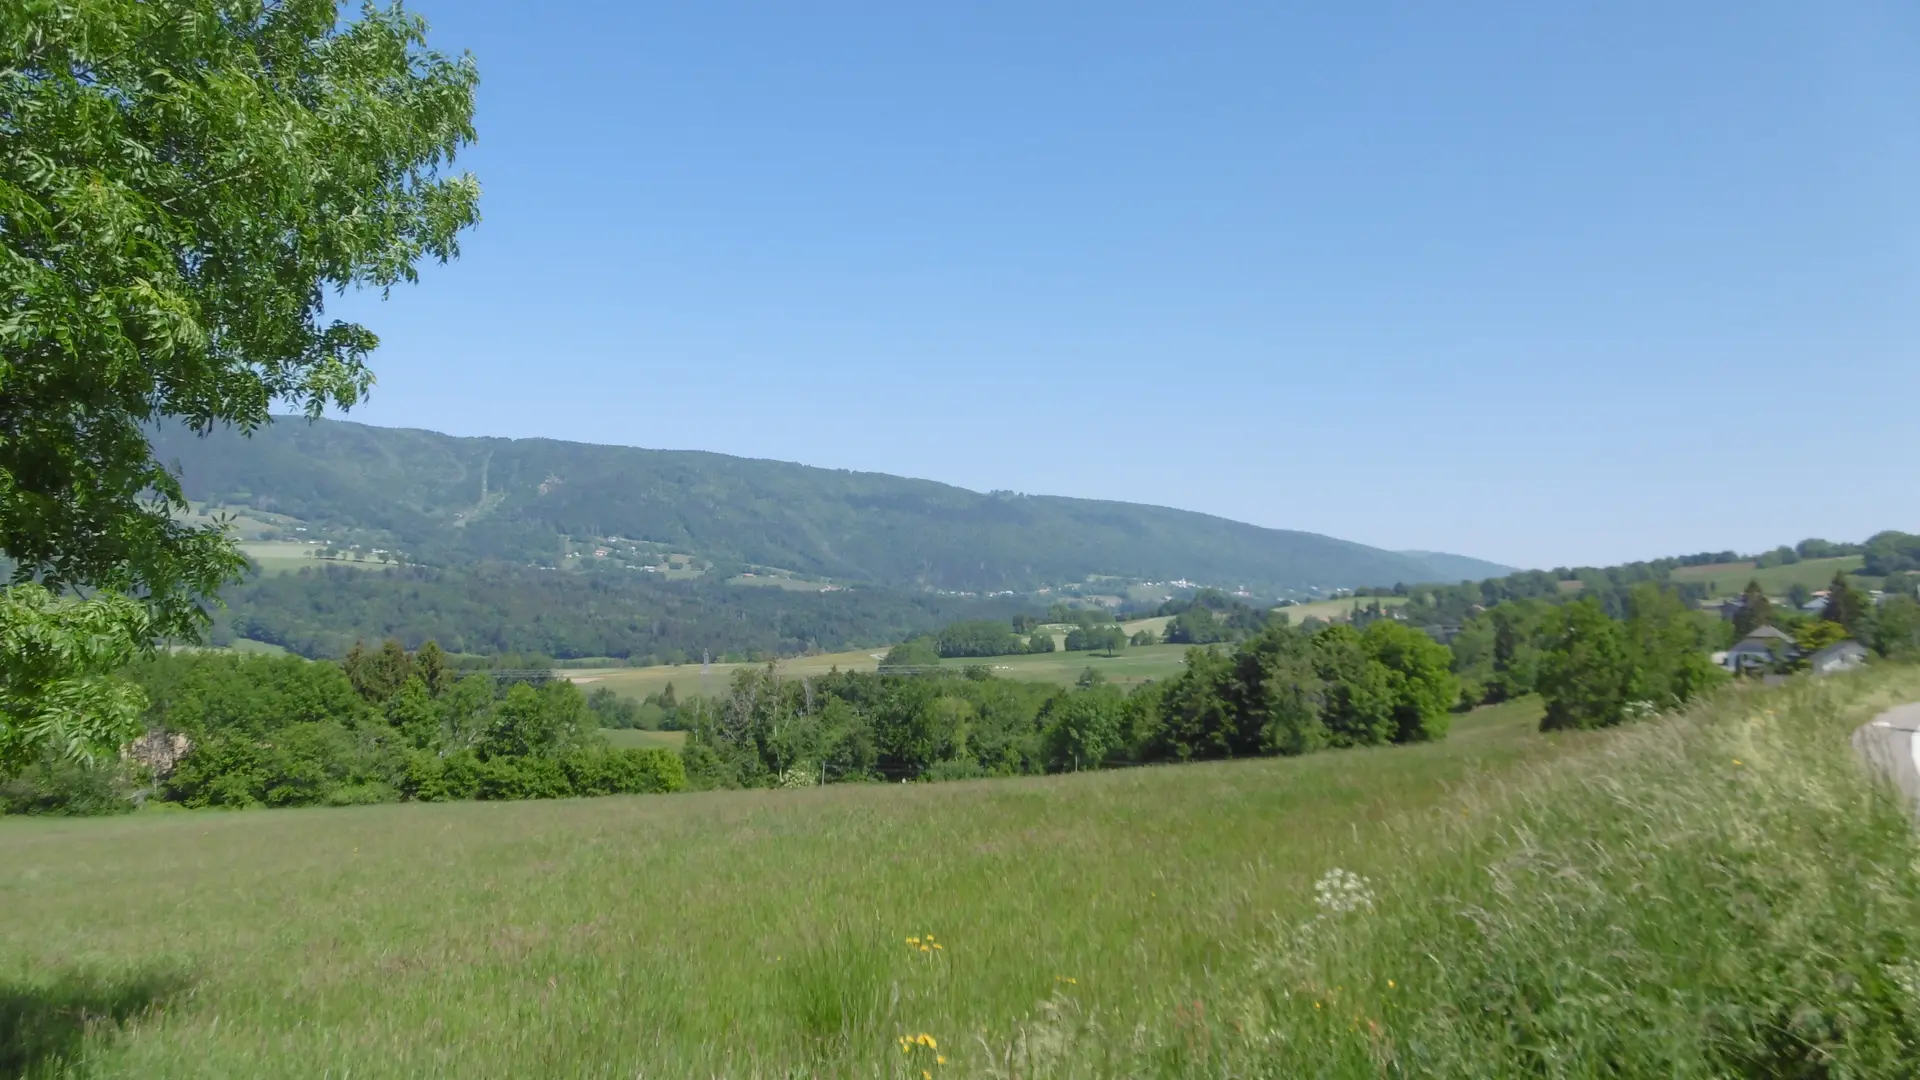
top-left (995, 669), bottom-right (1920, 1078)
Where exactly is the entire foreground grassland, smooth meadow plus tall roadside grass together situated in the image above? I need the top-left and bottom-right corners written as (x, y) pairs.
top-left (0, 669), bottom-right (1920, 1078)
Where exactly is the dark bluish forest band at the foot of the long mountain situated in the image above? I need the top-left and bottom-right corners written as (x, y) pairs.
top-left (217, 563), bottom-right (1025, 665)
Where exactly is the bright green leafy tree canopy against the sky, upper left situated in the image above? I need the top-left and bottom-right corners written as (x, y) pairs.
top-left (0, 0), bottom-right (480, 768)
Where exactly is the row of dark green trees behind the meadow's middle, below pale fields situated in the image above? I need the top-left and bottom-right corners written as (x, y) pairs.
top-left (674, 623), bottom-right (1459, 786)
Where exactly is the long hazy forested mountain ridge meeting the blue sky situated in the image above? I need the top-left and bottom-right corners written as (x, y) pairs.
top-left (154, 417), bottom-right (1501, 594)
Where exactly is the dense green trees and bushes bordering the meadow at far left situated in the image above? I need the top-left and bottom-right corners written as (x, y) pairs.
top-left (0, 642), bottom-right (685, 813)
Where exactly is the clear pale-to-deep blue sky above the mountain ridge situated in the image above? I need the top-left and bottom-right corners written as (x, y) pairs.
top-left (340, 0), bottom-right (1920, 567)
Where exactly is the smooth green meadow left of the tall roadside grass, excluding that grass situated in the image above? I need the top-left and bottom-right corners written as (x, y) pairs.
top-left (0, 691), bottom-right (1580, 1078)
